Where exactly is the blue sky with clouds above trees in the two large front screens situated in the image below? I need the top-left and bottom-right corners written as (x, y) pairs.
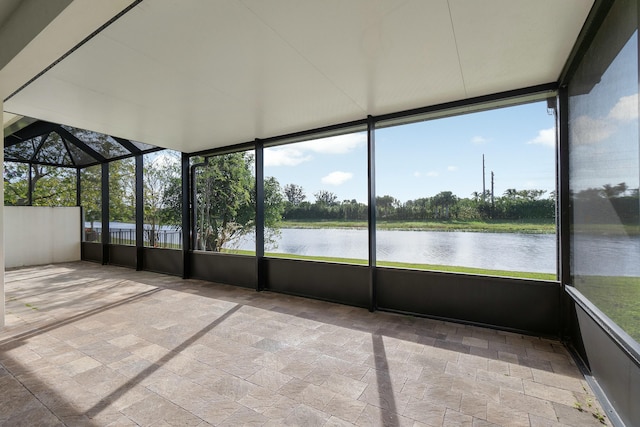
top-left (265, 102), bottom-right (555, 202)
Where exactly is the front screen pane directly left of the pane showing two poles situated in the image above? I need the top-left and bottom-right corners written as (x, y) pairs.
top-left (264, 131), bottom-right (368, 264)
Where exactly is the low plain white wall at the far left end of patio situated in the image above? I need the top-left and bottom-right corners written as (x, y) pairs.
top-left (4, 206), bottom-right (81, 268)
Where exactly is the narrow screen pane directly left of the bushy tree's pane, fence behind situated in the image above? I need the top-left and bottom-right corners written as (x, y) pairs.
top-left (144, 150), bottom-right (182, 249)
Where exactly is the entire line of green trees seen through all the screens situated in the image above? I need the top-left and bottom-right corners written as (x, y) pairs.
top-left (4, 152), bottom-right (639, 251)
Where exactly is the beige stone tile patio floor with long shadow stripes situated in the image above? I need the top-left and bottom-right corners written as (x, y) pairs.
top-left (0, 262), bottom-right (609, 427)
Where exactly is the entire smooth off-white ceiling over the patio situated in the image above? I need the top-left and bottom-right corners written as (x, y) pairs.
top-left (4, 0), bottom-right (593, 152)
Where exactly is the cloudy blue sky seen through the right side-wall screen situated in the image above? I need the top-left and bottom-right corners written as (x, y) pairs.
top-left (569, 31), bottom-right (640, 191)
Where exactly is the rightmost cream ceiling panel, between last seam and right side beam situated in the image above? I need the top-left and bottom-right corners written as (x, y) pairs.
top-left (449, 0), bottom-right (593, 97)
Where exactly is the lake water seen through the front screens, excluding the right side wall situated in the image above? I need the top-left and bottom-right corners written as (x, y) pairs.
top-left (232, 228), bottom-right (556, 273)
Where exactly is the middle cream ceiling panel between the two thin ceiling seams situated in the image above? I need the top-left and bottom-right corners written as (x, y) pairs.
top-left (244, 0), bottom-right (464, 114)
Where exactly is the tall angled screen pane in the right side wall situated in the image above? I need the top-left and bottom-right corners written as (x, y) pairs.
top-left (569, 1), bottom-right (640, 341)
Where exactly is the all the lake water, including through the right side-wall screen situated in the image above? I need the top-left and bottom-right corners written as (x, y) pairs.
top-left (99, 223), bottom-right (640, 276)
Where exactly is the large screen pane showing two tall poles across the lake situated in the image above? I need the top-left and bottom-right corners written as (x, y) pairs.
top-left (376, 102), bottom-right (556, 280)
